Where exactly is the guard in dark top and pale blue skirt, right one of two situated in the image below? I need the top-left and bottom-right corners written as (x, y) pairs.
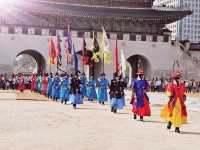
top-left (109, 73), bottom-right (125, 113)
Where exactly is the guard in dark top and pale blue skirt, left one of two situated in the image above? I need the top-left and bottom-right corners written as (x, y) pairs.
top-left (69, 73), bottom-right (83, 109)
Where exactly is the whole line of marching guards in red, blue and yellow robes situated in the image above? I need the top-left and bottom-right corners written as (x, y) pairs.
top-left (18, 69), bottom-right (187, 133)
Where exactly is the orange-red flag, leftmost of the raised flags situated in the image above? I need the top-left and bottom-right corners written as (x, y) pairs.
top-left (48, 36), bottom-right (56, 64)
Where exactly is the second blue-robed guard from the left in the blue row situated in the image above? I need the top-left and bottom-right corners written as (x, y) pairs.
top-left (52, 72), bottom-right (61, 101)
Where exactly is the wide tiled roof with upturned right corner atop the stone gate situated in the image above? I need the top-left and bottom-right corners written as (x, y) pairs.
top-left (0, 0), bottom-right (191, 27)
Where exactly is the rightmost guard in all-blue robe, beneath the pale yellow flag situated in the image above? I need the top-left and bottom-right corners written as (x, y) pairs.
top-left (97, 73), bottom-right (109, 105)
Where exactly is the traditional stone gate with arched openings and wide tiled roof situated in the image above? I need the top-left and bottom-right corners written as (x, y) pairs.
top-left (0, 0), bottom-right (200, 79)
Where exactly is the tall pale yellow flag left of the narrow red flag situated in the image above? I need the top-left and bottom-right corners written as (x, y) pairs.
top-left (100, 27), bottom-right (111, 64)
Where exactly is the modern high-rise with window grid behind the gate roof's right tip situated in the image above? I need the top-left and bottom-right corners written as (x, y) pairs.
top-left (155, 0), bottom-right (200, 43)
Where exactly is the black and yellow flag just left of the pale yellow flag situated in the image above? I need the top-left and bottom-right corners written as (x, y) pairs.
top-left (91, 32), bottom-right (100, 63)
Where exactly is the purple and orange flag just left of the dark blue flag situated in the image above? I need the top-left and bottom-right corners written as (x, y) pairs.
top-left (64, 28), bottom-right (72, 64)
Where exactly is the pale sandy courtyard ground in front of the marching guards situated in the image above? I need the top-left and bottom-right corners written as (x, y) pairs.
top-left (0, 92), bottom-right (200, 150)
